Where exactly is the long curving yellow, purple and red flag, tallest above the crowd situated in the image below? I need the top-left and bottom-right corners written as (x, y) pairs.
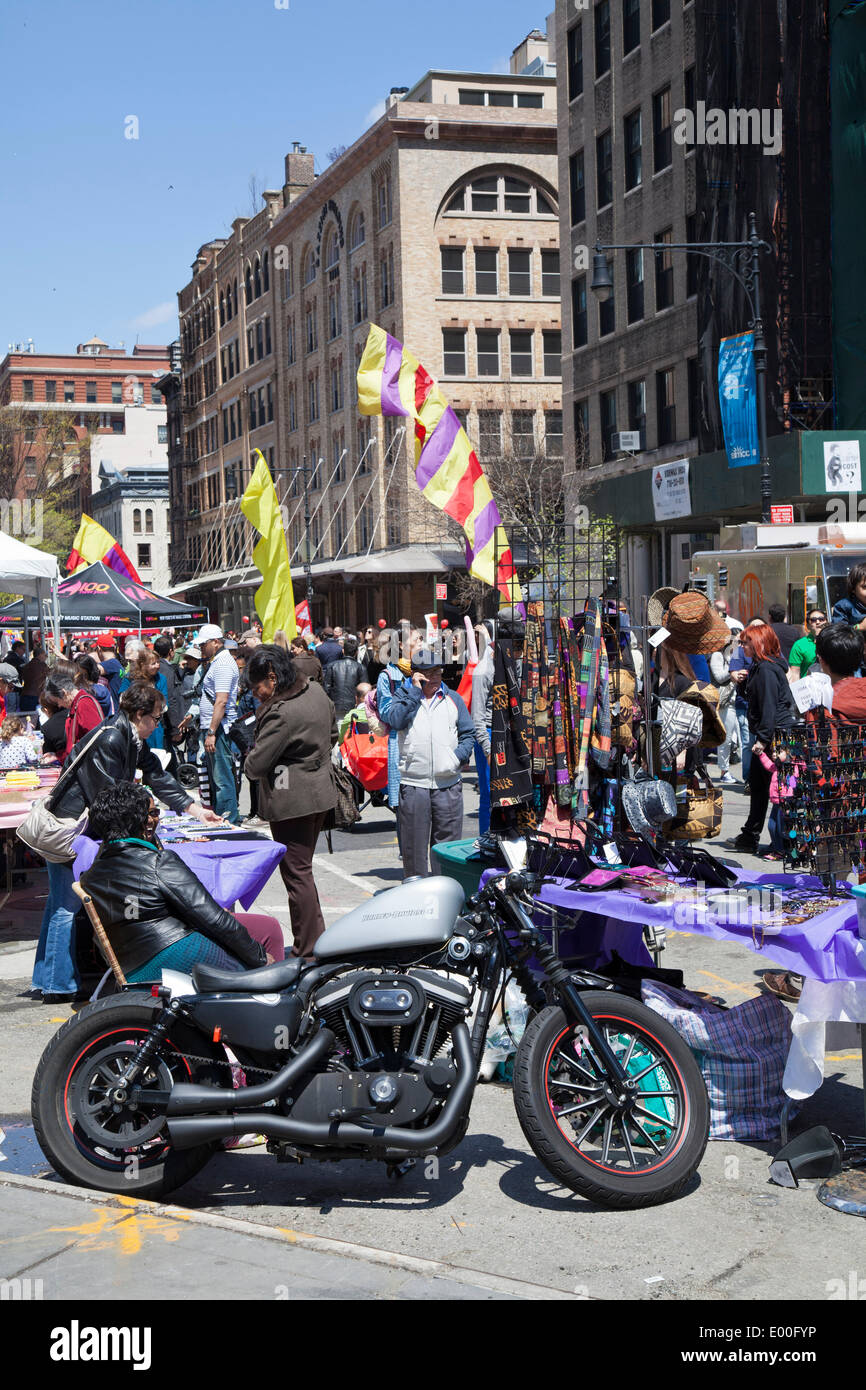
top-left (357, 324), bottom-right (521, 605)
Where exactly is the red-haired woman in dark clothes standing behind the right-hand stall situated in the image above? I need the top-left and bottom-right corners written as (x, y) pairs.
top-left (734, 623), bottom-right (796, 855)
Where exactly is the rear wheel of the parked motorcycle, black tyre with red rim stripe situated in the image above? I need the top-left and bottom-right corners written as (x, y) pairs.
top-left (31, 992), bottom-right (224, 1197)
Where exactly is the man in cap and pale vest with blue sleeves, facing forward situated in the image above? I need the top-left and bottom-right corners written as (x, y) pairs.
top-left (386, 648), bottom-right (475, 878)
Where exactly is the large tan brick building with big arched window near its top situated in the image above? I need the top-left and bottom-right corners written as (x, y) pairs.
top-left (163, 32), bottom-right (562, 626)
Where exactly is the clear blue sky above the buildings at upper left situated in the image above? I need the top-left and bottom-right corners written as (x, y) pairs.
top-left (0, 0), bottom-right (553, 356)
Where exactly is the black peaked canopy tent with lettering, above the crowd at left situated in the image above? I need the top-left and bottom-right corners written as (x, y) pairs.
top-left (0, 560), bottom-right (209, 632)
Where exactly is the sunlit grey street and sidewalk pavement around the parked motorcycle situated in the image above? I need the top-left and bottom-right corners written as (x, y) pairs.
top-left (0, 777), bottom-right (863, 1301)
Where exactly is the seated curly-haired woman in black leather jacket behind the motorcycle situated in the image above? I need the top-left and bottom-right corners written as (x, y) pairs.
top-left (81, 781), bottom-right (267, 983)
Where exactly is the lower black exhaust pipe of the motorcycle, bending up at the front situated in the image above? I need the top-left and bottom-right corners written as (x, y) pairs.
top-left (168, 1023), bottom-right (477, 1154)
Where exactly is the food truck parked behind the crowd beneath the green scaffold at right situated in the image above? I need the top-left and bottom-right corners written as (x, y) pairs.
top-left (689, 521), bottom-right (866, 623)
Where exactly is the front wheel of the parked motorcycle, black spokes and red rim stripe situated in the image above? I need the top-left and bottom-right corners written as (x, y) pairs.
top-left (514, 990), bottom-right (709, 1208)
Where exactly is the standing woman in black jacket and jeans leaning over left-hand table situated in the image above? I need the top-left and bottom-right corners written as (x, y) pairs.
top-left (32, 682), bottom-right (220, 1004)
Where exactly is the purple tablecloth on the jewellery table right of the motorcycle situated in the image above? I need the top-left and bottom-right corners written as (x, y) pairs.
top-left (482, 870), bottom-right (866, 983)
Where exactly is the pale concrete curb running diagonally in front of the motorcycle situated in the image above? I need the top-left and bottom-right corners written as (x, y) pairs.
top-left (0, 1172), bottom-right (587, 1302)
